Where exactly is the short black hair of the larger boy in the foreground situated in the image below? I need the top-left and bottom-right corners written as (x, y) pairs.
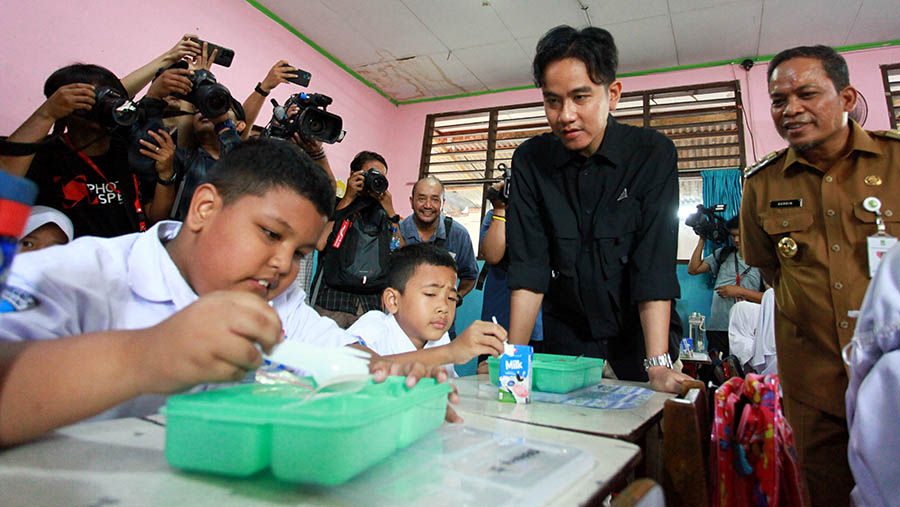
top-left (206, 137), bottom-right (334, 217)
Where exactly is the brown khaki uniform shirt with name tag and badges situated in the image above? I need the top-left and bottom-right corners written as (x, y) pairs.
top-left (740, 122), bottom-right (900, 417)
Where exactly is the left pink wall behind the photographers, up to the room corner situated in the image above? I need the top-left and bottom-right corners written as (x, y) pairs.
top-left (0, 0), bottom-right (394, 178)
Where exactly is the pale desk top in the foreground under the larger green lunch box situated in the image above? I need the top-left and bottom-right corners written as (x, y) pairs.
top-left (0, 411), bottom-right (640, 507)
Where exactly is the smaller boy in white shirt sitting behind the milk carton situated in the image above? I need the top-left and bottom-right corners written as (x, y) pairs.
top-left (347, 243), bottom-right (506, 377)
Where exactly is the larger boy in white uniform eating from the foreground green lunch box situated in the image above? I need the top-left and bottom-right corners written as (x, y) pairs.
top-left (0, 139), bottom-right (455, 446)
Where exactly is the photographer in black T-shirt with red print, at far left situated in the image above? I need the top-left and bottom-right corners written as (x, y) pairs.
top-left (0, 64), bottom-right (185, 237)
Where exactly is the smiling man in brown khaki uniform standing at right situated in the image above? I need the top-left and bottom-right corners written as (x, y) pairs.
top-left (741, 46), bottom-right (900, 505)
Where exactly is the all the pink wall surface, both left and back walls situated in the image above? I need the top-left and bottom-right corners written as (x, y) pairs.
top-left (7, 0), bottom-right (900, 215)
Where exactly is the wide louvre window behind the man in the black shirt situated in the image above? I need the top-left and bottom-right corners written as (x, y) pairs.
top-left (419, 81), bottom-right (745, 250)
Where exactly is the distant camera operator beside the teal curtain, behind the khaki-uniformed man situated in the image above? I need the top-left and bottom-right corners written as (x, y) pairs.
top-left (688, 214), bottom-right (765, 358)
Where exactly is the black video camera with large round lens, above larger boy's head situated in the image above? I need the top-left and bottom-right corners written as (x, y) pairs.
top-left (263, 93), bottom-right (347, 144)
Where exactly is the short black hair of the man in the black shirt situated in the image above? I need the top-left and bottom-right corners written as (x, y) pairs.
top-left (531, 25), bottom-right (619, 88)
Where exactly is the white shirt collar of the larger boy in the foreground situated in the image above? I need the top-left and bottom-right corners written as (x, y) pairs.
top-left (128, 220), bottom-right (197, 309)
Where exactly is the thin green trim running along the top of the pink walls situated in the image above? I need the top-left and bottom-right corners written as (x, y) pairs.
top-left (239, 0), bottom-right (900, 106)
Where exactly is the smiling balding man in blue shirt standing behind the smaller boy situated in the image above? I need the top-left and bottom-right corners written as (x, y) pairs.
top-left (400, 176), bottom-right (478, 339)
